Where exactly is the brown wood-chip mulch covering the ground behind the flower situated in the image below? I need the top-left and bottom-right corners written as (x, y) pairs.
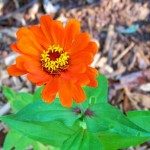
top-left (0, 0), bottom-right (150, 150)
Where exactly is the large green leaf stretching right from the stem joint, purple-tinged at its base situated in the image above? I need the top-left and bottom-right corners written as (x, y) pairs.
top-left (85, 103), bottom-right (150, 137)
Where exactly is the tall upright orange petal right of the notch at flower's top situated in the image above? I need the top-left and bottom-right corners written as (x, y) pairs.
top-left (64, 19), bottom-right (80, 50)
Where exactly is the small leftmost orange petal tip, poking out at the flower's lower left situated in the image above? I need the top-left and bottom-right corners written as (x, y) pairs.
top-left (7, 65), bottom-right (27, 76)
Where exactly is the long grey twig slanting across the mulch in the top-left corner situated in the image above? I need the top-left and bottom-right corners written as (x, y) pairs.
top-left (0, 0), bottom-right (37, 21)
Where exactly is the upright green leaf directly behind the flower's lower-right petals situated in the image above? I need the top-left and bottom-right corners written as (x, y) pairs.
top-left (82, 74), bottom-right (108, 108)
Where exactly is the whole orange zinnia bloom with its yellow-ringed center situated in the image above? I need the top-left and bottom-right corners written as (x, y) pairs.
top-left (7, 15), bottom-right (98, 107)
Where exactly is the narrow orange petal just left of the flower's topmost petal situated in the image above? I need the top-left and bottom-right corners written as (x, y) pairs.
top-left (29, 25), bottom-right (50, 49)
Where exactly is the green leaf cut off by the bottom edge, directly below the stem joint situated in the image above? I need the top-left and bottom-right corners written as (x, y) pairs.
top-left (61, 129), bottom-right (103, 150)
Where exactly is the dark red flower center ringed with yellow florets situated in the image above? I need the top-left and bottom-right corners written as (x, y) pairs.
top-left (41, 45), bottom-right (69, 75)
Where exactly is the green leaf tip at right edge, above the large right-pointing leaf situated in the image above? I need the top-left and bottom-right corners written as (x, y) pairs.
top-left (127, 110), bottom-right (150, 132)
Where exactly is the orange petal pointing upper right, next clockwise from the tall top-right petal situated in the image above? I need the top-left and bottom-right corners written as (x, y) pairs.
top-left (67, 32), bottom-right (90, 55)
